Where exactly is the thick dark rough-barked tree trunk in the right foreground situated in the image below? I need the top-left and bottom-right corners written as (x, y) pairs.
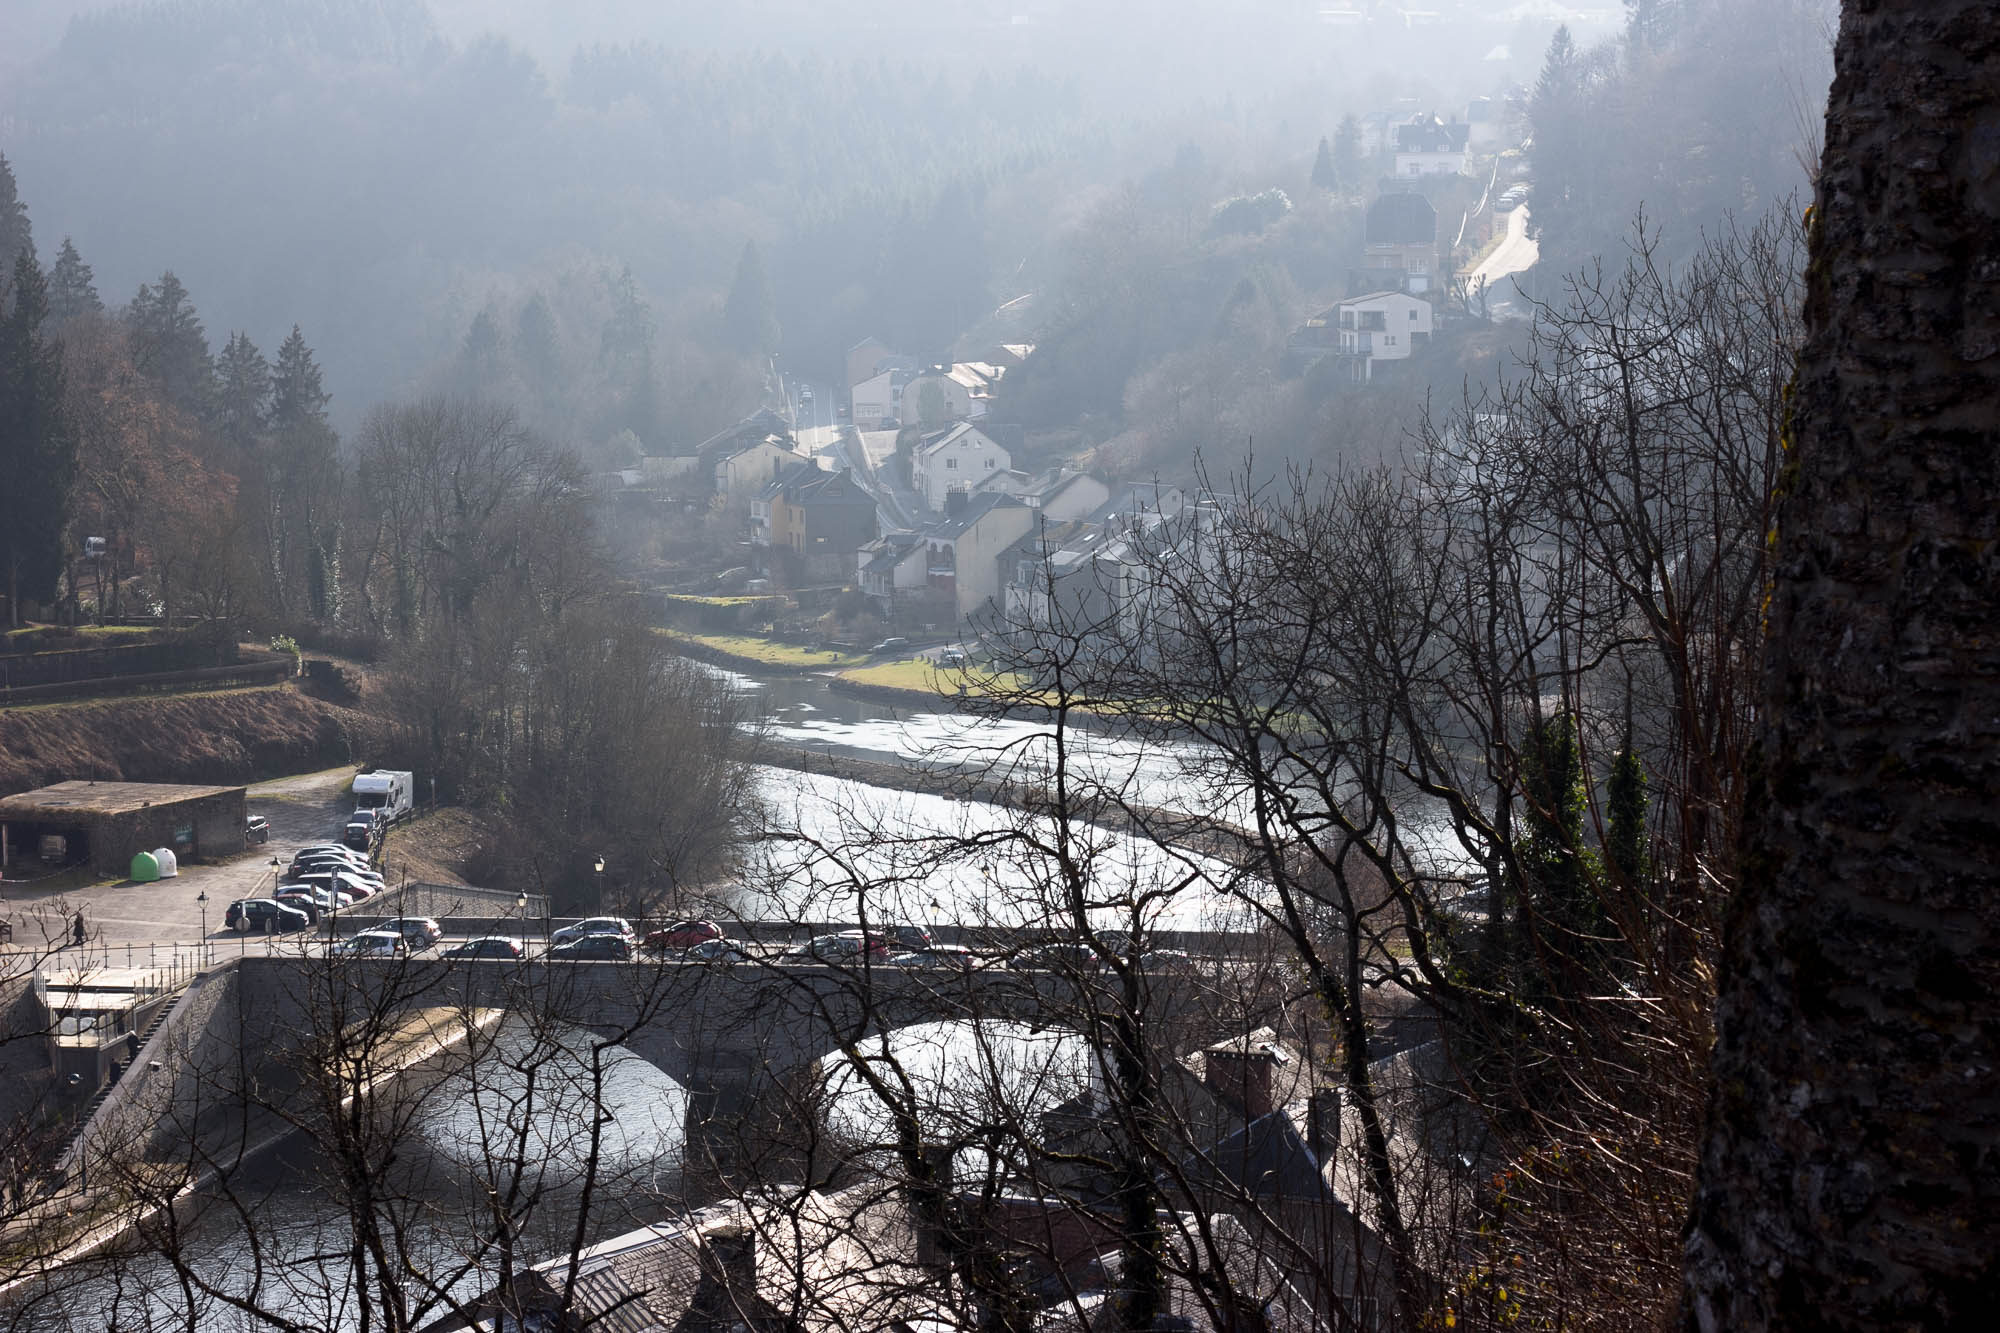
top-left (1686, 0), bottom-right (2000, 1331)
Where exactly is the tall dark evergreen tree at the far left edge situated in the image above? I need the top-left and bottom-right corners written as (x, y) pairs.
top-left (0, 250), bottom-right (76, 626)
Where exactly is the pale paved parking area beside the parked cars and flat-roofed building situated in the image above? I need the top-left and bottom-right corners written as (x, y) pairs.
top-left (4, 769), bottom-right (354, 965)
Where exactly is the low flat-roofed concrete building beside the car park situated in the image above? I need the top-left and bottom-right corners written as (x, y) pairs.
top-left (0, 781), bottom-right (244, 879)
